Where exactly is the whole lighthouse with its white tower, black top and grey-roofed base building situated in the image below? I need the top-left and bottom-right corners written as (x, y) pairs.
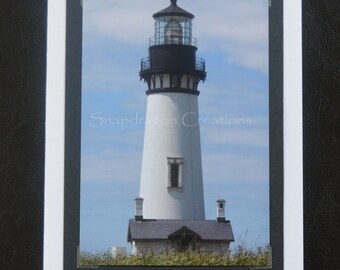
top-left (128, 0), bottom-right (234, 254)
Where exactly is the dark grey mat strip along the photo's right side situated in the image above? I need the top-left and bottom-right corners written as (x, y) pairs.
top-left (269, 0), bottom-right (284, 270)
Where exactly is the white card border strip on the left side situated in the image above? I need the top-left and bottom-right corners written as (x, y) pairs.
top-left (43, 0), bottom-right (66, 270)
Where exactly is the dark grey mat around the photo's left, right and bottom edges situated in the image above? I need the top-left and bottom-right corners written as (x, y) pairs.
top-left (64, 0), bottom-right (283, 270)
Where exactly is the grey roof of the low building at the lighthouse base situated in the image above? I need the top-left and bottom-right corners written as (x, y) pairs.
top-left (128, 219), bottom-right (234, 242)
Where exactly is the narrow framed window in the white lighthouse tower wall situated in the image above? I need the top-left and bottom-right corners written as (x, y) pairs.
top-left (168, 157), bottom-right (183, 189)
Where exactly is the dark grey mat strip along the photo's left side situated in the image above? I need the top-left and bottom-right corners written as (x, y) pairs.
top-left (64, 0), bottom-right (82, 270)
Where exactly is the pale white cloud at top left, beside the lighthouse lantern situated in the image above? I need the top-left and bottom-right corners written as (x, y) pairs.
top-left (84, 0), bottom-right (164, 44)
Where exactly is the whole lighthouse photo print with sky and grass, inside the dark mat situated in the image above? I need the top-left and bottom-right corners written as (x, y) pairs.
top-left (79, 0), bottom-right (271, 267)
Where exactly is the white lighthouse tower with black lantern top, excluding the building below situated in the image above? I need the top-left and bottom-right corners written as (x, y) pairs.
top-left (139, 1), bottom-right (206, 220)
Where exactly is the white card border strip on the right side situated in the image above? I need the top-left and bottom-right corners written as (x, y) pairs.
top-left (282, 0), bottom-right (303, 270)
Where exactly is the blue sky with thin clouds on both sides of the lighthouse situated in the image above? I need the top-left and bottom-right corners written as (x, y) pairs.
top-left (80, 0), bottom-right (269, 252)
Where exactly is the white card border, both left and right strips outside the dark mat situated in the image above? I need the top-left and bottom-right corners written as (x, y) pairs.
top-left (43, 0), bottom-right (303, 270)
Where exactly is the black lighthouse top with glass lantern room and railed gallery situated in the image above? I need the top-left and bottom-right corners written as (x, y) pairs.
top-left (139, 0), bottom-right (207, 95)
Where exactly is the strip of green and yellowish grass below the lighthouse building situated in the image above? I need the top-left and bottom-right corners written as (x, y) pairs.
top-left (79, 245), bottom-right (270, 266)
